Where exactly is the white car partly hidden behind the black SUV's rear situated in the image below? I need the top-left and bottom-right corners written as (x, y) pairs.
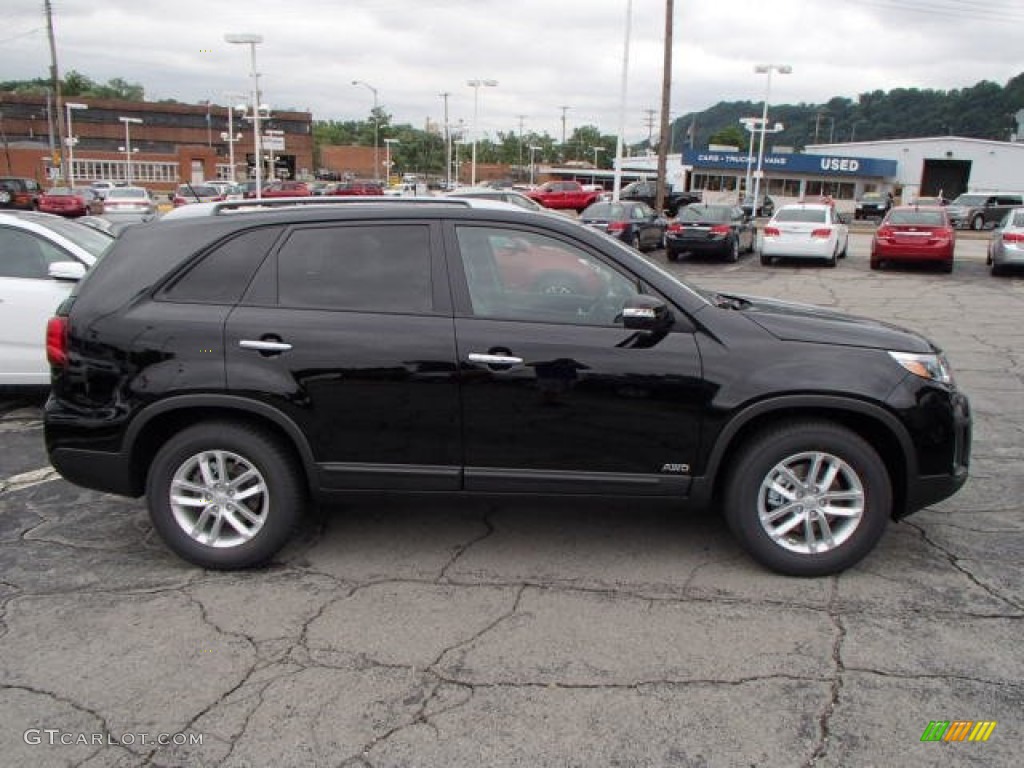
top-left (0, 211), bottom-right (114, 386)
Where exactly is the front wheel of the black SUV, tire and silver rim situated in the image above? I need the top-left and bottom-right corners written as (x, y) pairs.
top-left (724, 421), bottom-right (892, 577)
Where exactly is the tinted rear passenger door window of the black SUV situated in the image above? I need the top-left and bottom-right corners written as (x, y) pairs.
top-left (278, 224), bottom-right (433, 312)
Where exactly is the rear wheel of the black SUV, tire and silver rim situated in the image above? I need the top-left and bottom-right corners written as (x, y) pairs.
top-left (145, 422), bottom-right (305, 570)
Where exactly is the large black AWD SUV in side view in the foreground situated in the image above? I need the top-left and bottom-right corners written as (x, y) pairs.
top-left (45, 198), bottom-right (971, 575)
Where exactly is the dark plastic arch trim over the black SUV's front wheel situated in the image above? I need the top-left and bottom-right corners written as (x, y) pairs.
top-left (705, 395), bottom-right (916, 518)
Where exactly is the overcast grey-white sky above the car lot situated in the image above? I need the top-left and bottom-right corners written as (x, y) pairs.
top-left (0, 0), bottom-right (1024, 141)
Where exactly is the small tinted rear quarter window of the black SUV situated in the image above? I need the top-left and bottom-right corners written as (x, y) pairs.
top-left (161, 226), bottom-right (281, 304)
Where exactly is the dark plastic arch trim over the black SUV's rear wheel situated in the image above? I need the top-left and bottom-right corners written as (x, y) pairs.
top-left (125, 394), bottom-right (317, 497)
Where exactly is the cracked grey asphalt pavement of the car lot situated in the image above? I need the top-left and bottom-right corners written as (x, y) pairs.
top-left (0, 236), bottom-right (1024, 768)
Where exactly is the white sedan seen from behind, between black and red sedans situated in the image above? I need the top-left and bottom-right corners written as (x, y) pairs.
top-left (761, 203), bottom-right (850, 266)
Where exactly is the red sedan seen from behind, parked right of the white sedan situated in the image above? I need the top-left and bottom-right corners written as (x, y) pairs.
top-left (871, 206), bottom-right (956, 272)
